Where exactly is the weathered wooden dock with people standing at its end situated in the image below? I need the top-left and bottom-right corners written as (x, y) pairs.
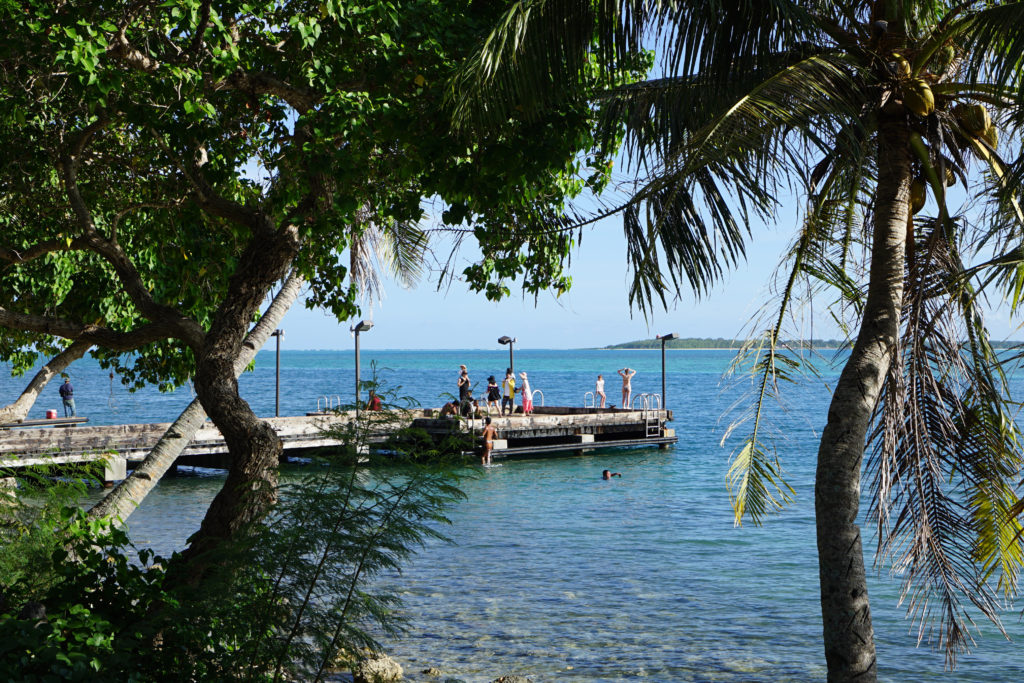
top-left (0, 407), bottom-right (677, 480)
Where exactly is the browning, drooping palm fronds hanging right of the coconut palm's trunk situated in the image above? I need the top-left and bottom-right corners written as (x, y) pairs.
top-left (867, 219), bottom-right (1022, 665)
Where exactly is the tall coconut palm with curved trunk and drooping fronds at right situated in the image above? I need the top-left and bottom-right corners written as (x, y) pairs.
top-left (451, 0), bottom-right (1024, 681)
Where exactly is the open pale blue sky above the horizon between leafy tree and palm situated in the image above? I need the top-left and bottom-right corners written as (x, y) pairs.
top-left (281, 209), bottom-right (838, 349)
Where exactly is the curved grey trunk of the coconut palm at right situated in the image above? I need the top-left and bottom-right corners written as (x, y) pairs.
top-left (814, 112), bottom-right (911, 683)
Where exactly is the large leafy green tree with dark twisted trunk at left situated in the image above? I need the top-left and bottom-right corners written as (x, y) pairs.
top-left (0, 0), bottom-right (622, 568)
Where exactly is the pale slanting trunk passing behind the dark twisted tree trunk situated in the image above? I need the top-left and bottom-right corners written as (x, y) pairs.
top-left (89, 272), bottom-right (304, 523)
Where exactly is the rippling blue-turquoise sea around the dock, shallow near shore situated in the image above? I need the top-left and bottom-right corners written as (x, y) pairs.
top-left (0, 350), bottom-right (1024, 683)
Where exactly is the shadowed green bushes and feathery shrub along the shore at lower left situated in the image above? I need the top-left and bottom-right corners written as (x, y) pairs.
top-left (0, 382), bottom-right (463, 681)
